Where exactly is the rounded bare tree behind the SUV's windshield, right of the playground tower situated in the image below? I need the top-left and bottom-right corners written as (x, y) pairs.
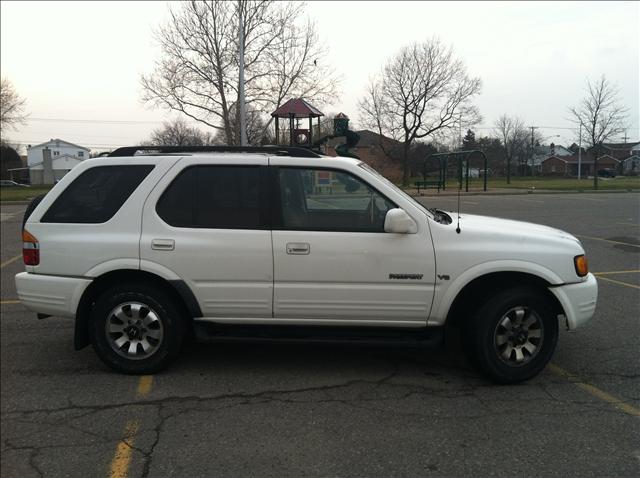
top-left (359, 38), bottom-right (481, 186)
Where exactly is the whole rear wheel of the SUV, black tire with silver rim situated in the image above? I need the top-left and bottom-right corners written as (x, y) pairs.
top-left (89, 284), bottom-right (185, 375)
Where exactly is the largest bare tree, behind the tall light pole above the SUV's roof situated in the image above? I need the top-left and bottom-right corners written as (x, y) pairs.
top-left (141, 0), bottom-right (338, 145)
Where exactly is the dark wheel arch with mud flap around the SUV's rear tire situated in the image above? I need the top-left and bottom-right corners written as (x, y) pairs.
top-left (74, 269), bottom-right (202, 350)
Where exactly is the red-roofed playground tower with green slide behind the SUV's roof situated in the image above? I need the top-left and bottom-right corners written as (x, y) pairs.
top-left (271, 98), bottom-right (360, 159)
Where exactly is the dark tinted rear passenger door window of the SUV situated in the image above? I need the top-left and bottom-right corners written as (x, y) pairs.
top-left (156, 166), bottom-right (264, 229)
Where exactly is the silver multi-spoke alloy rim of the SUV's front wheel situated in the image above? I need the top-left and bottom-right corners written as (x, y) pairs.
top-left (493, 305), bottom-right (544, 367)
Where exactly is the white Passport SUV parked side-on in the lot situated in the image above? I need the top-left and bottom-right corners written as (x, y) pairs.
top-left (16, 147), bottom-right (597, 383)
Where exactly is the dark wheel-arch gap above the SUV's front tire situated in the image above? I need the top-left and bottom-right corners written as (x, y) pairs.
top-left (446, 271), bottom-right (564, 326)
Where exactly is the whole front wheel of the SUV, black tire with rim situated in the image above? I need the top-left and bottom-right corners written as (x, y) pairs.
top-left (462, 286), bottom-right (558, 384)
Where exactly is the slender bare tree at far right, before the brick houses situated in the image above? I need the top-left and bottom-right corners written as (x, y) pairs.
top-left (569, 75), bottom-right (628, 189)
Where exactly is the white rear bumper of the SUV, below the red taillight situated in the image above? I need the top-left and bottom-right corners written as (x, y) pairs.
top-left (16, 272), bottom-right (91, 317)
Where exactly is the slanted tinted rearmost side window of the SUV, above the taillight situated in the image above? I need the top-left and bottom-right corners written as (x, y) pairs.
top-left (40, 165), bottom-right (153, 224)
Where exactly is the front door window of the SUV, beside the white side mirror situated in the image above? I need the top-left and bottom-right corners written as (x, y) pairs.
top-left (278, 168), bottom-right (396, 232)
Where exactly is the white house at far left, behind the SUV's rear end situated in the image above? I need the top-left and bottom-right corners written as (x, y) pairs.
top-left (27, 138), bottom-right (90, 184)
